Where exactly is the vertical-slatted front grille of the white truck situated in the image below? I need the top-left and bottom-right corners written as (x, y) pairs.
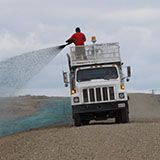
top-left (82, 87), bottom-right (115, 102)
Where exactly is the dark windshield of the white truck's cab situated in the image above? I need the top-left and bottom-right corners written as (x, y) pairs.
top-left (77, 67), bottom-right (118, 82)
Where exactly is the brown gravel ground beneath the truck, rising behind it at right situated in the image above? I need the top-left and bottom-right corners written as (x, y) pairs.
top-left (0, 94), bottom-right (160, 160)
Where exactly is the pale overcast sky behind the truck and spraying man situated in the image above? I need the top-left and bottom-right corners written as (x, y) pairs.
top-left (0, 0), bottom-right (160, 95)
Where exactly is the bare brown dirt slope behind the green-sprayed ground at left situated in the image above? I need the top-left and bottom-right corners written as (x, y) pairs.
top-left (0, 96), bottom-right (48, 120)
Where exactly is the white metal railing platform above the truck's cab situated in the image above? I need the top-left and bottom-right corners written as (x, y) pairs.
top-left (70, 42), bottom-right (121, 66)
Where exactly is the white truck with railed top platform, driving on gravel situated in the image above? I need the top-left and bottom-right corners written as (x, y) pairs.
top-left (63, 39), bottom-right (131, 126)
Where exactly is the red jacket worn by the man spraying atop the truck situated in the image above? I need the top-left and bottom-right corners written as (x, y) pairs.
top-left (68, 32), bottom-right (86, 46)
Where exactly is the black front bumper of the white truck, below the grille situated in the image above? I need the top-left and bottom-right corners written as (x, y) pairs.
top-left (72, 101), bottom-right (128, 114)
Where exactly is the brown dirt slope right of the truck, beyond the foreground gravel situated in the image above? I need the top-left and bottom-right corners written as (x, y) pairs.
top-left (129, 93), bottom-right (160, 121)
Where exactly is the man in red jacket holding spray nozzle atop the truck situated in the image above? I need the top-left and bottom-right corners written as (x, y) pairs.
top-left (66, 27), bottom-right (87, 60)
